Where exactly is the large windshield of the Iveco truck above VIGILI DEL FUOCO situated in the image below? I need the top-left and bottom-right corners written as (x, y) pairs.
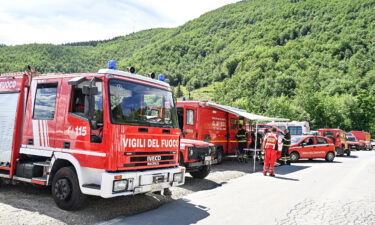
top-left (109, 79), bottom-right (178, 128)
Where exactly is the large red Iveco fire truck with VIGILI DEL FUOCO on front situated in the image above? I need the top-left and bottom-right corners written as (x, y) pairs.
top-left (0, 61), bottom-right (185, 210)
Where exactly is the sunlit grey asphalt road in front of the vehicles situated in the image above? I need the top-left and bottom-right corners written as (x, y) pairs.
top-left (100, 151), bottom-right (375, 225)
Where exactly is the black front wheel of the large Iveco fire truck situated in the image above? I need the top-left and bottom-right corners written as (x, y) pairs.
top-left (52, 167), bottom-right (85, 210)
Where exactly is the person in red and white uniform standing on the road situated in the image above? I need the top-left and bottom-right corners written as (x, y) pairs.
top-left (263, 128), bottom-right (279, 177)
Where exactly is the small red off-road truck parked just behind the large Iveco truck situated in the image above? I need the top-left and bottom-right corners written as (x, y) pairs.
top-left (179, 139), bottom-right (216, 179)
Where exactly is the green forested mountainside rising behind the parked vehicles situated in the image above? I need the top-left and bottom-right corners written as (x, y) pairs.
top-left (0, 0), bottom-right (375, 135)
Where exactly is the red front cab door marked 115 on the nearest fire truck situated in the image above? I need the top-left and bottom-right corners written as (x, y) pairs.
top-left (56, 79), bottom-right (107, 168)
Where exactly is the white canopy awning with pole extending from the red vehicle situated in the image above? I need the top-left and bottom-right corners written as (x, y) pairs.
top-left (207, 102), bottom-right (289, 172)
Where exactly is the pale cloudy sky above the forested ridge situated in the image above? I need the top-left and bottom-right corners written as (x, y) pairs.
top-left (0, 0), bottom-right (239, 45)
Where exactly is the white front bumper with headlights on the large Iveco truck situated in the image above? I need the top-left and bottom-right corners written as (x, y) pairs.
top-left (98, 166), bottom-right (185, 198)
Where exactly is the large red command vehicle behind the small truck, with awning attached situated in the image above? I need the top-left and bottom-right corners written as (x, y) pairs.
top-left (177, 101), bottom-right (251, 163)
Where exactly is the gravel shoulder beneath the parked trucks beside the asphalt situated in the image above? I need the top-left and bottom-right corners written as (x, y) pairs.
top-left (0, 157), bottom-right (259, 225)
